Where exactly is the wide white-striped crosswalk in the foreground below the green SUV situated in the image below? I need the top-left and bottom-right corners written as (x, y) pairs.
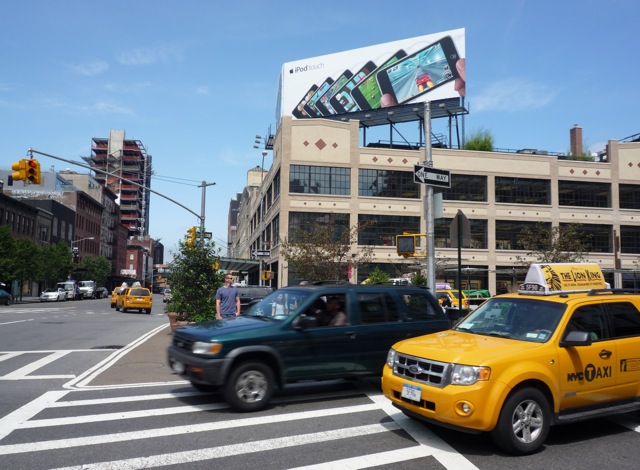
top-left (0, 386), bottom-right (476, 470)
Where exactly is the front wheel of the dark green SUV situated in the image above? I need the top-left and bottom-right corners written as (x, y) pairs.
top-left (224, 362), bottom-right (274, 412)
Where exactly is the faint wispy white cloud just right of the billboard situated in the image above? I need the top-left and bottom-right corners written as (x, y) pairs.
top-left (470, 78), bottom-right (556, 112)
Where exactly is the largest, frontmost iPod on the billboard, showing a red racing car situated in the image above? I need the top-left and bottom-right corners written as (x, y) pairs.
top-left (376, 36), bottom-right (460, 104)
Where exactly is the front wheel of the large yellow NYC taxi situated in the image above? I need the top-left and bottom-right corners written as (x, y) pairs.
top-left (491, 388), bottom-right (551, 455)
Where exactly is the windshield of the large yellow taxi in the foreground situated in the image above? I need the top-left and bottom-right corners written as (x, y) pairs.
top-left (454, 297), bottom-right (566, 343)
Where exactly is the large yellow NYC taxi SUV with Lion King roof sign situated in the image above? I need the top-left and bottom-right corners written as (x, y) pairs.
top-left (382, 263), bottom-right (640, 455)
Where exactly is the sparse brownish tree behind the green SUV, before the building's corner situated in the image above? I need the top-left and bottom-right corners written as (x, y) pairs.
top-left (280, 222), bottom-right (373, 282)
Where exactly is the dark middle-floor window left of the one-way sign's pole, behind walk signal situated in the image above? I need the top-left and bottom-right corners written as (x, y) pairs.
top-left (358, 214), bottom-right (420, 246)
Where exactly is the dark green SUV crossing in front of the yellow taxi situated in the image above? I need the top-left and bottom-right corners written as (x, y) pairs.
top-left (168, 284), bottom-right (450, 411)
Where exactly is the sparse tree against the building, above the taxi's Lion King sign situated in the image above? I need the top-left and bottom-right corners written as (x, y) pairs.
top-left (517, 223), bottom-right (590, 265)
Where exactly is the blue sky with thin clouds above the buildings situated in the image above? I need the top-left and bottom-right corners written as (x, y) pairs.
top-left (0, 0), bottom-right (640, 258)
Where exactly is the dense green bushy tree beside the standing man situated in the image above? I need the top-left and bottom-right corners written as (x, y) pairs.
top-left (165, 241), bottom-right (223, 322)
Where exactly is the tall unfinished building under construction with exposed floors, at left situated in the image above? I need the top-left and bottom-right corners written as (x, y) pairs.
top-left (84, 130), bottom-right (151, 240)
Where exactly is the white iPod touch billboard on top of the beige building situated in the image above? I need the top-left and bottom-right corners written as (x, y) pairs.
top-left (277, 28), bottom-right (466, 122)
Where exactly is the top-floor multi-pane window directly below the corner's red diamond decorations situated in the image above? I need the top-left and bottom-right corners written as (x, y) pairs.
top-left (289, 165), bottom-right (351, 196)
